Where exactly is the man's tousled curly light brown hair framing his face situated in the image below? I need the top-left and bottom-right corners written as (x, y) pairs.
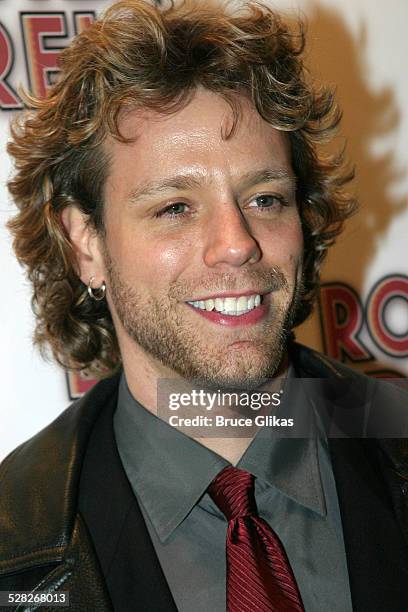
top-left (8, 0), bottom-right (356, 377)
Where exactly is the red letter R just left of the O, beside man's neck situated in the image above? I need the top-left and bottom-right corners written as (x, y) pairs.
top-left (319, 283), bottom-right (372, 361)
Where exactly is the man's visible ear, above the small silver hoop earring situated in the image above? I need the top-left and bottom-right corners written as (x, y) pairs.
top-left (61, 204), bottom-right (105, 287)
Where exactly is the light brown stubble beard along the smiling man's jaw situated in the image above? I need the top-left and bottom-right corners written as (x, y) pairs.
top-left (104, 251), bottom-right (301, 391)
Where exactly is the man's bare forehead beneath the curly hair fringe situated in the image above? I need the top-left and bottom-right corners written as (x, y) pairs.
top-left (106, 89), bottom-right (291, 188)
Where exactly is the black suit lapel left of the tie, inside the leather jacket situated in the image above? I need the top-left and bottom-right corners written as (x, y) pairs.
top-left (79, 376), bottom-right (176, 612)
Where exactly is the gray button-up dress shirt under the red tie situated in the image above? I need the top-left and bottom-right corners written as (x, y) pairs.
top-left (114, 376), bottom-right (352, 612)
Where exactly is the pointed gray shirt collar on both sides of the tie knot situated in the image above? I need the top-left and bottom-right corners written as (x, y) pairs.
top-left (114, 368), bottom-right (326, 542)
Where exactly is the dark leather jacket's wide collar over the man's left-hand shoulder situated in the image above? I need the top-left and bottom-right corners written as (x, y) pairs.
top-left (0, 370), bottom-right (118, 574)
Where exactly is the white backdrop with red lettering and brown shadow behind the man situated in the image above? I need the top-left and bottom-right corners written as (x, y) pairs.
top-left (0, 0), bottom-right (408, 460)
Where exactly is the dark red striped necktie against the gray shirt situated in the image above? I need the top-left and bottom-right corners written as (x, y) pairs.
top-left (208, 466), bottom-right (304, 612)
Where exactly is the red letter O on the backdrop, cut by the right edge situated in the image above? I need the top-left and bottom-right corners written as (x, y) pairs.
top-left (367, 274), bottom-right (408, 358)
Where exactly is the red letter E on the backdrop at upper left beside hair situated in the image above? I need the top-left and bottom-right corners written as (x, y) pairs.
top-left (21, 12), bottom-right (67, 98)
